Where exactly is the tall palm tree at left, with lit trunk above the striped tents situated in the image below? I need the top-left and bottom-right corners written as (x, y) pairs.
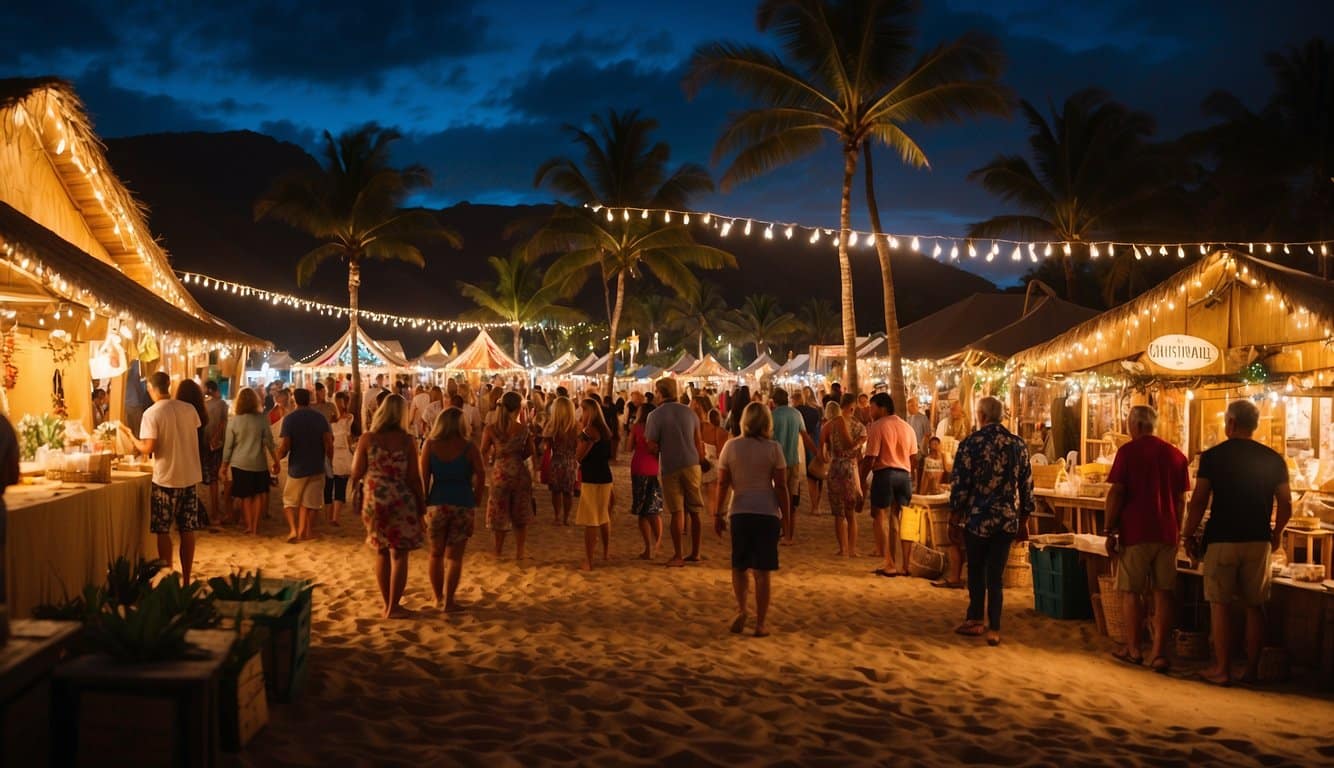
top-left (255, 123), bottom-right (463, 419)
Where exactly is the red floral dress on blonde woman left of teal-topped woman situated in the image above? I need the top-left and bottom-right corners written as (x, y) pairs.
top-left (362, 443), bottom-right (423, 551)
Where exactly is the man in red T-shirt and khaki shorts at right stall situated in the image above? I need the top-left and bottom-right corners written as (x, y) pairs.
top-left (1107, 405), bottom-right (1190, 672)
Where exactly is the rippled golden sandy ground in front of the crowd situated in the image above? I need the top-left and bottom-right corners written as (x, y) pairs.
top-left (197, 464), bottom-right (1334, 767)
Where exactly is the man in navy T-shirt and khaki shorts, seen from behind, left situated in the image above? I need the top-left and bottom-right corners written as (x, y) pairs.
top-left (277, 389), bottom-right (333, 544)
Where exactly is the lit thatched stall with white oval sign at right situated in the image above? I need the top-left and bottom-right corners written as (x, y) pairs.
top-left (1007, 251), bottom-right (1334, 576)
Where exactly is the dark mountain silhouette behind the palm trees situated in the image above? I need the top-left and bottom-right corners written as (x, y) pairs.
top-left (107, 131), bottom-right (995, 357)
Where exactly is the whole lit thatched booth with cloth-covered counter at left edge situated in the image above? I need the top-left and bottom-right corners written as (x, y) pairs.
top-left (0, 79), bottom-right (268, 617)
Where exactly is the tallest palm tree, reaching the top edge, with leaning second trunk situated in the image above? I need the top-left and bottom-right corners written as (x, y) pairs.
top-left (686, 0), bottom-right (1009, 400)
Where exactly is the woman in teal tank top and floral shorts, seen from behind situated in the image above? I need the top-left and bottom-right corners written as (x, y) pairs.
top-left (420, 408), bottom-right (487, 613)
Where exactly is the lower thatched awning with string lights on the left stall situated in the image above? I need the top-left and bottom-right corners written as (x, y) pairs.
top-left (0, 201), bottom-right (269, 347)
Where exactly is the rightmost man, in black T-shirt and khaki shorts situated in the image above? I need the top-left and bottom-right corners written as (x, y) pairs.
top-left (1182, 400), bottom-right (1293, 685)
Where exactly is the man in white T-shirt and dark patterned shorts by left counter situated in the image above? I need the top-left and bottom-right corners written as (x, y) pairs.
top-left (135, 371), bottom-right (208, 584)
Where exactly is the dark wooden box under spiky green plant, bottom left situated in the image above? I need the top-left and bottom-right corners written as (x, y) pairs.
top-left (52, 631), bottom-right (236, 768)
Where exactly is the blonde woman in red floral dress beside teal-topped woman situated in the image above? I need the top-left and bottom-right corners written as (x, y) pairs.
top-left (351, 395), bottom-right (426, 619)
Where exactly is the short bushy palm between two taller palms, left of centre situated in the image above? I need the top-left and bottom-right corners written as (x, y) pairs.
top-left (459, 253), bottom-right (584, 361)
